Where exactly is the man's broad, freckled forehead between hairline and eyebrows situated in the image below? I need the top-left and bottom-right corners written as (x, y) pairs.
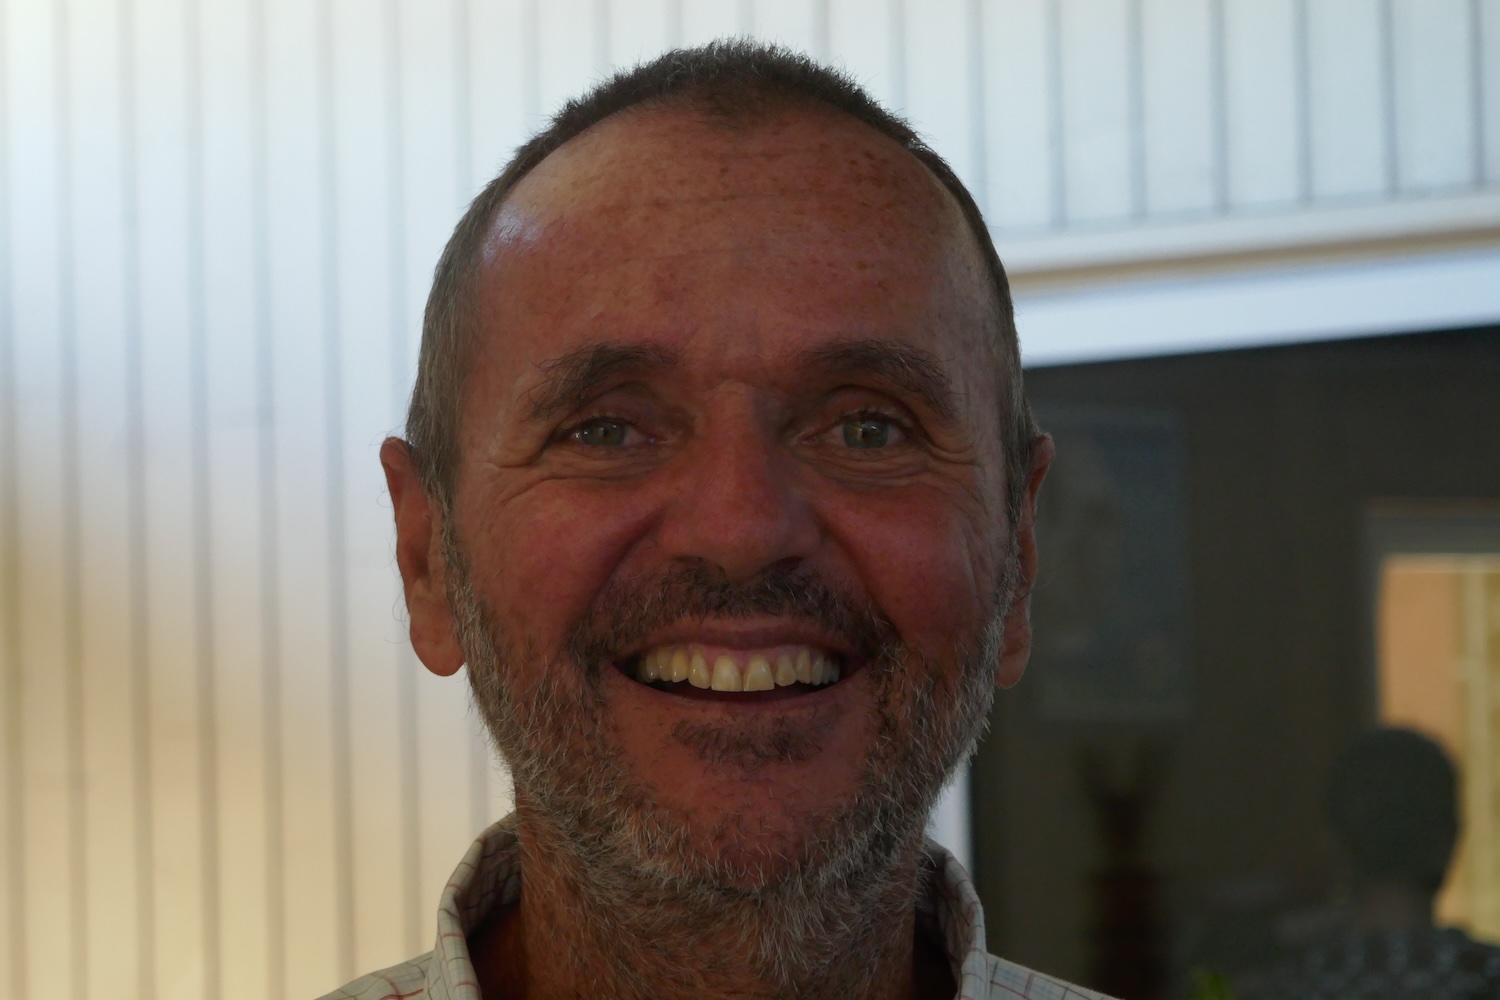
top-left (479, 106), bottom-right (993, 407)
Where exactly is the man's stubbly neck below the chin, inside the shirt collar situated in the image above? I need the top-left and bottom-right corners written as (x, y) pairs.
top-left (470, 814), bottom-right (953, 1000)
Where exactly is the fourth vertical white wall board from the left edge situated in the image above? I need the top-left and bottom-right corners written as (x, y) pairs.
top-left (198, 0), bottom-right (279, 1000)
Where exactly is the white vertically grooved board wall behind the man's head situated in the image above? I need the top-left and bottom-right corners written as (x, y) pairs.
top-left (0, 0), bottom-right (1500, 1000)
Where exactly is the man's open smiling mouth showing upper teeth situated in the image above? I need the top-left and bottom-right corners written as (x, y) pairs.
top-left (617, 643), bottom-right (851, 697)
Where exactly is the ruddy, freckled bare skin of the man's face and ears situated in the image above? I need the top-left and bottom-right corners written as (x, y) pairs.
top-left (383, 109), bottom-right (1050, 1000)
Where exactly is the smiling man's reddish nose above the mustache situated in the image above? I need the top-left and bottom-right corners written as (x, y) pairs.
top-left (657, 410), bottom-right (822, 582)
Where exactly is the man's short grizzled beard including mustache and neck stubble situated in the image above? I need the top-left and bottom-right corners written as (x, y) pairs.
top-left (444, 519), bottom-right (1016, 999)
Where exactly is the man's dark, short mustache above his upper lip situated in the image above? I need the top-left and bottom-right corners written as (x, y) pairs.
top-left (567, 562), bottom-right (902, 679)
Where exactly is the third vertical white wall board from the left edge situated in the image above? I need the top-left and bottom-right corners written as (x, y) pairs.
top-left (134, 0), bottom-right (213, 1000)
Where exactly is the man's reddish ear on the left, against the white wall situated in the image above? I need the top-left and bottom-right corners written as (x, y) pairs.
top-left (380, 438), bottom-right (464, 678)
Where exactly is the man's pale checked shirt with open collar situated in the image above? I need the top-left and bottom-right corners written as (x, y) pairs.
top-left (323, 817), bottom-right (1109, 1000)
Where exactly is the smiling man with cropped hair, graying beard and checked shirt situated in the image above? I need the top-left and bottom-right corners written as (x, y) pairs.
top-left (322, 43), bottom-right (1095, 1000)
